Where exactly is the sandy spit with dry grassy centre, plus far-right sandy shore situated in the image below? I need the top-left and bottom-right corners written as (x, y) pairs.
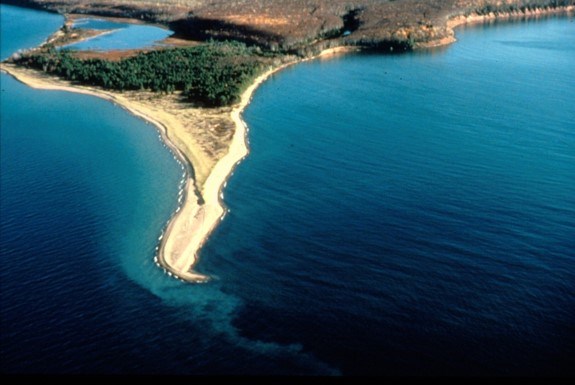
top-left (5, 6), bottom-right (575, 283)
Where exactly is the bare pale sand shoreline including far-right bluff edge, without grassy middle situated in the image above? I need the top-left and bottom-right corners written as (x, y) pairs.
top-left (0, 6), bottom-right (575, 283)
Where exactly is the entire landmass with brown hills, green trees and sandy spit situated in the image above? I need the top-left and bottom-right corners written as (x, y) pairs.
top-left (1, 0), bottom-right (575, 283)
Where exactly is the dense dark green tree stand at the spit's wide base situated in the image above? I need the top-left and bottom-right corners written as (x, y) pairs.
top-left (14, 42), bottom-right (262, 107)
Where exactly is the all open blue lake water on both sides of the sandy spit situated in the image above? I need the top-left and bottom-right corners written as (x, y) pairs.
top-left (0, 5), bottom-right (575, 375)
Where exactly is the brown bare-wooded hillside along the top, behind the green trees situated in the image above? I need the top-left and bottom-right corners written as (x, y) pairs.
top-left (7, 0), bottom-right (575, 53)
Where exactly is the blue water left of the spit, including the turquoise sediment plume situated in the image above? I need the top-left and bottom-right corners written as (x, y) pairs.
top-left (0, 4), bottom-right (336, 374)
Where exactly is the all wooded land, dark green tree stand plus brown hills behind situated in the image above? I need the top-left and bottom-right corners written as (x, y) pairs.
top-left (4, 0), bottom-right (575, 107)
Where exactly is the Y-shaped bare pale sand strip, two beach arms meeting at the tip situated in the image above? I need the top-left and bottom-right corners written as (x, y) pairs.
top-left (0, 62), bottom-right (295, 282)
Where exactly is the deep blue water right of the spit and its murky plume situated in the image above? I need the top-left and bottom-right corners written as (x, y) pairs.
top-left (202, 19), bottom-right (575, 375)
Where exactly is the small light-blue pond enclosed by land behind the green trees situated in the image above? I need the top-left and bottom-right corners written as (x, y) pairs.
top-left (66, 19), bottom-right (172, 51)
